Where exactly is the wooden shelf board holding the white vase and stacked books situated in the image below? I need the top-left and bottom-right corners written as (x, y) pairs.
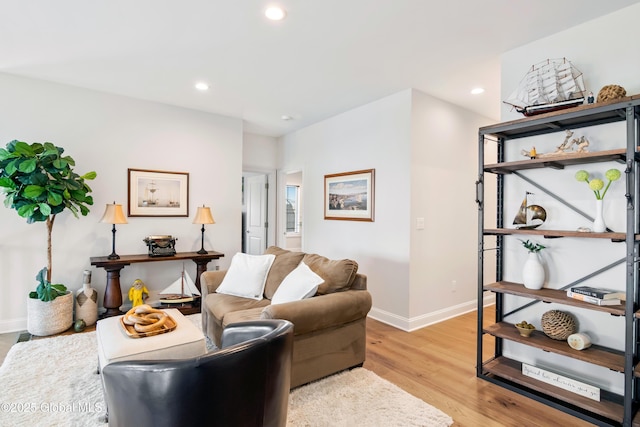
top-left (483, 281), bottom-right (625, 316)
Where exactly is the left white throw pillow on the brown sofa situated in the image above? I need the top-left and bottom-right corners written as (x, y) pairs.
top-left (216, 252), bottom-right (276, 300)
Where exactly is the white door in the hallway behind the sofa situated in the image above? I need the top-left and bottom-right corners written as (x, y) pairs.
top-left (244, 175), bottom-right (267, 255)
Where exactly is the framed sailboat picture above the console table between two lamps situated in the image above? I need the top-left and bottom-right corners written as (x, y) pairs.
top-left (127, 168), bottom-right (189, 217)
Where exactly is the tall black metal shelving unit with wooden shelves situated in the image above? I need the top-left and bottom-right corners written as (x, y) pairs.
top-left (476, 95), bottom-right (640, 426)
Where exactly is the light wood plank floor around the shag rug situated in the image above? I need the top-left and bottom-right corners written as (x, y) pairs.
top-left (0, 312), bottom-right (591, 427)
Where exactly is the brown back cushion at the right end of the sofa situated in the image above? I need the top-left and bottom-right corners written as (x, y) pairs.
top-left (302, 254), bottom-right (358, 295)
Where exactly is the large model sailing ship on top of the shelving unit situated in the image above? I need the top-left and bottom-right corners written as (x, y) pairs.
top-left (504, 58), bottom-right (586, 116)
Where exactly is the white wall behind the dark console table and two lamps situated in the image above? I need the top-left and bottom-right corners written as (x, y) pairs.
top-left (0, 74), bottom-right (243, 332)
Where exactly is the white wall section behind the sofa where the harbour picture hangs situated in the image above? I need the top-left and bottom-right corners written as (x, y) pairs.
top-left (281, 90), bottom-right (411, 319)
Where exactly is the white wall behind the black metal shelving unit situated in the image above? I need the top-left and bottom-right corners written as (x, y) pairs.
top-left (502, 4), bottom-right (640, 393)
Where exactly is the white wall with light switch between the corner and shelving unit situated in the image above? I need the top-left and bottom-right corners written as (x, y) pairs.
top-left (410, 91), bottom-right (492, 329)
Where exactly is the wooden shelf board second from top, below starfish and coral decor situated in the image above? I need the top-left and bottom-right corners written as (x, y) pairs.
top-left (484, 148), bottom-right (627, 174)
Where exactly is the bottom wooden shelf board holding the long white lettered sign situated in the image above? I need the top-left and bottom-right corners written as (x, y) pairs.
top-left (483, 357), bottom-right (624, 423)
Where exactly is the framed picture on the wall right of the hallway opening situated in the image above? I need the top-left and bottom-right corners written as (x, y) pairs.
top-left (324, 169), bottom-right (375, 222)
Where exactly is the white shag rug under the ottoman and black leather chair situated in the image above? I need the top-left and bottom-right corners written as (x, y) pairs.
top-left (0, 316), bottom-right (453, 427)
